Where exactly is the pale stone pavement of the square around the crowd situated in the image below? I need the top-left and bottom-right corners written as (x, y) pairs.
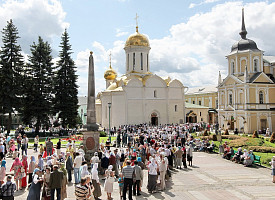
top-left (7, 150), bottom-right (275, 200)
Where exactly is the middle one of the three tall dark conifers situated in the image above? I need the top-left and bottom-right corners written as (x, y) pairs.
top-left (27, 36), bottom-right (54, 133)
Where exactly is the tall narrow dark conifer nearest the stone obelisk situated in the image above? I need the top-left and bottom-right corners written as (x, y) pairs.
top-left (54, 30), bottom-right (78, 128)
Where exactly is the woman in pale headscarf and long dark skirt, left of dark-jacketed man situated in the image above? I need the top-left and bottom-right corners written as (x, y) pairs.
top-left (27, 168), bottom-right (43, 200)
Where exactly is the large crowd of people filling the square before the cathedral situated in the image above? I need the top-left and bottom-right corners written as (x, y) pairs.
top-left (0, 121), bottom-right (275, 200)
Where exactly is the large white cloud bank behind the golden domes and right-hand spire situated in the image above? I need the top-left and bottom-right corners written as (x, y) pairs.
top-left (76, 2), bottom-right (275, 94)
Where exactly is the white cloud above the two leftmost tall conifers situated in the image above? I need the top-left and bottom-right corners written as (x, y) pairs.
top-left (0, 0), bottom-right (69, 53)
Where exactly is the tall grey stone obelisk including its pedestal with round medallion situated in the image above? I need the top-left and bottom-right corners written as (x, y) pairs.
top-left (83, 51), bottom-right (100, 160)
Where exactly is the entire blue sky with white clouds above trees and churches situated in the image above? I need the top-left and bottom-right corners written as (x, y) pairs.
top-left (0, 0), bottom-right (275, 95)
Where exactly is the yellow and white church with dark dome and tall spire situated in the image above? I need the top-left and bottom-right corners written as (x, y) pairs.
top-left (218, 9), bottom-right (275, 133)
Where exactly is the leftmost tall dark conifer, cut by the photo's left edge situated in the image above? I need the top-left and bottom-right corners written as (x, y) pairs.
top-left (0, 20), bottom-right (24, 133)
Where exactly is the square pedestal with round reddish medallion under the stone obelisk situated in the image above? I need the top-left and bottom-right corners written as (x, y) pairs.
top-left (83, 131), bottom-right (100, 162)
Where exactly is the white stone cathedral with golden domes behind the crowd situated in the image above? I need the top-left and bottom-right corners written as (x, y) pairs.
top-left (96, 26), bottom-right (186, 127)
